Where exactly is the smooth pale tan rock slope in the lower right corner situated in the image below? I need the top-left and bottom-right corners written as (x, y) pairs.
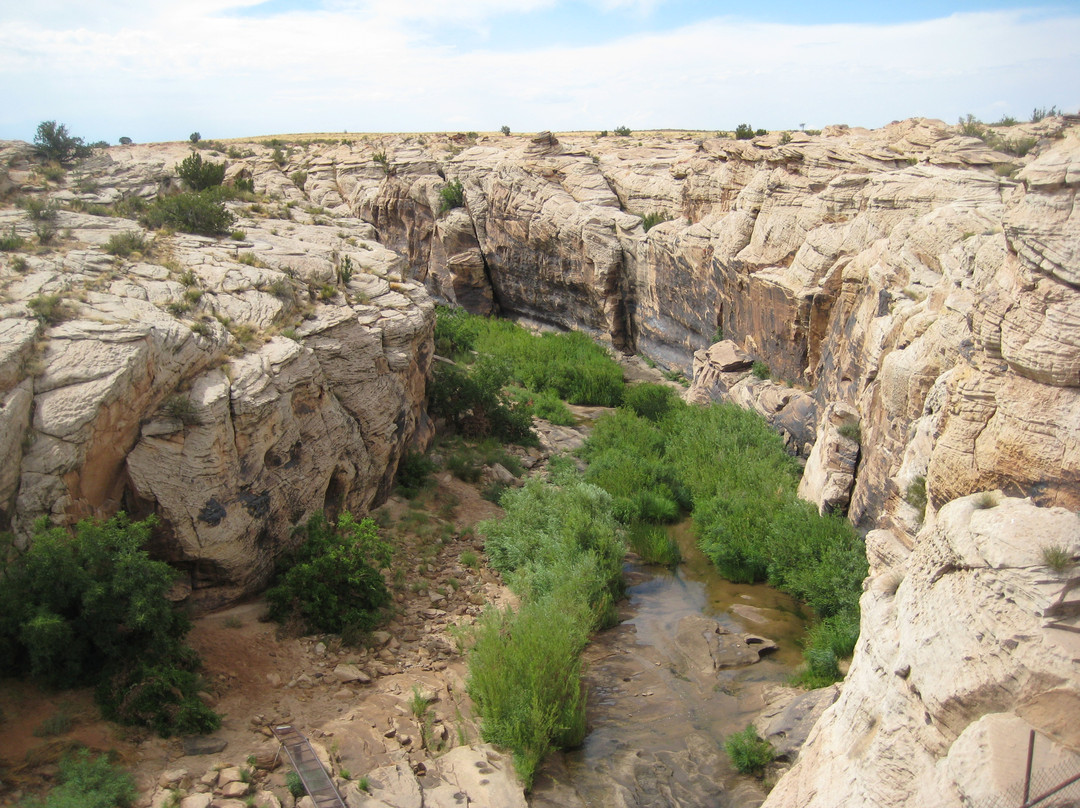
top-left (766, 495), bottom-right (1080, 808)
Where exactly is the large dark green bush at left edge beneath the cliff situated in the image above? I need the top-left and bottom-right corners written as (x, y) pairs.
top-left (0, 514), bottom-right (220, 736)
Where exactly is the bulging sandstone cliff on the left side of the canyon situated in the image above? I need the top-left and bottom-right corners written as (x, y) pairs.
top-left (0, 145), bottom-right (434, 606)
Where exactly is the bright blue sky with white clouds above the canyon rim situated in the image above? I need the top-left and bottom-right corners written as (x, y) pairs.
top-left (0, 0), bottom-right (1080, 143)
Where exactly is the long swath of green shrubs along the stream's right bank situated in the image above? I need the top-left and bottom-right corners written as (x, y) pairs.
top-left (582, 397), bottom-right (866, 682)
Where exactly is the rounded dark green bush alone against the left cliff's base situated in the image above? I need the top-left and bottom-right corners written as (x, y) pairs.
top-left (267, 511), bottom-right (391, 637)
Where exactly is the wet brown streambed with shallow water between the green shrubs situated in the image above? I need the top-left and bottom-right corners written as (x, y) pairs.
top-left (529, 523), bottom-right (807, 808)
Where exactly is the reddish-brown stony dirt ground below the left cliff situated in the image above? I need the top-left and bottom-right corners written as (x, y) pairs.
top-left (0, 464), bottom-right (511, 806)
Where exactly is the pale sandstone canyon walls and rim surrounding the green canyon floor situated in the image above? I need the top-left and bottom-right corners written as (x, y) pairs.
top-left (0, 117), bottom-right (1080, 807)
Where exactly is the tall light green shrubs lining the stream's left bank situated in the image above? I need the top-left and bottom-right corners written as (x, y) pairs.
top-left (469, 477), bottom-right (624, 787)
